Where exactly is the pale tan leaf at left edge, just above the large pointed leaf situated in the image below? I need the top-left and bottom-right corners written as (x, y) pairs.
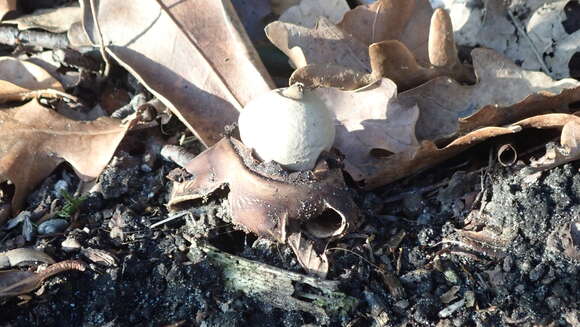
top-left (0, 57), bottom-right (63, 103)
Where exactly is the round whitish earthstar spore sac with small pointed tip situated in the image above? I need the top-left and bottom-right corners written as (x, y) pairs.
top-left (239, 84), bottom-right (335, 170)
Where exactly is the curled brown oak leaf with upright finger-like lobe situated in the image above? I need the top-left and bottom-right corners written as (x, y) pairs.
top-left (290, 9), bottom-right (475, 91)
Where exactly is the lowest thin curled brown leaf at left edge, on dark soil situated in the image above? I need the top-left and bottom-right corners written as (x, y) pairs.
top-left (0, 260), bottom-right (85, 298)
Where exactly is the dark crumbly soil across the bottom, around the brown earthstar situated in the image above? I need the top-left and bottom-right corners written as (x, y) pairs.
top-left (0, 137), bottom-right (580, 326)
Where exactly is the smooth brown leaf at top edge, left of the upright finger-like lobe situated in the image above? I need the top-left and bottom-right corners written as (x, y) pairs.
top-left (338, 0), bottom-right (433, 63)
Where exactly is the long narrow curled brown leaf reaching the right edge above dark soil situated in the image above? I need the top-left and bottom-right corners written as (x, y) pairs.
top-left (360, 113), bottom-right (579, 189)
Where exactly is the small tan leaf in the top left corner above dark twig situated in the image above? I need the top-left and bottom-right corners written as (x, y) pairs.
top-left (3, 7), bottom-right (81, 33)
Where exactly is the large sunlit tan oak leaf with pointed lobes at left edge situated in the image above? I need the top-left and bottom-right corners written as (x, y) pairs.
top-left (0, 99), bottom-right (131, 211)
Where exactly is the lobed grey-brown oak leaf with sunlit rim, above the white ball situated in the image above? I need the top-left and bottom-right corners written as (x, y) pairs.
top-left (266, 17), bottom-right (371, 73)
